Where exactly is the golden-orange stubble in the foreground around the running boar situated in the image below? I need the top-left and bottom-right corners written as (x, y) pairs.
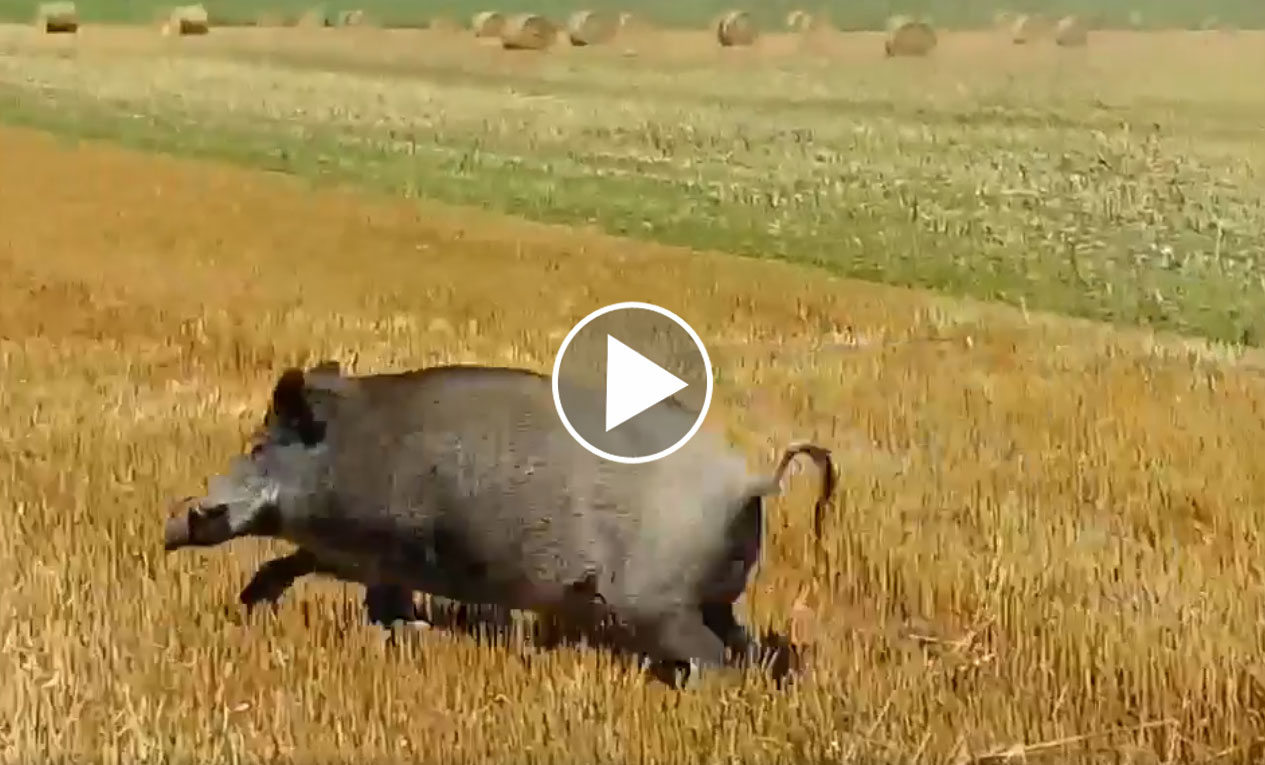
top-left (0, 115), bottom-right (1265, 762)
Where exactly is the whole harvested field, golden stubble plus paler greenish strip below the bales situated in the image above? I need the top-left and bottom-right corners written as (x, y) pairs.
top-left (0, 16), bottom-right (1265, 765)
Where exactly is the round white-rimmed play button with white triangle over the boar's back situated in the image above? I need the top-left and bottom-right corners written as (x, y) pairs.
top-left (553, 302), bottom-right (712, 464)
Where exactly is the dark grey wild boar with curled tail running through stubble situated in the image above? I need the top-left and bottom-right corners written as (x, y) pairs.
top-left (166, 363), bottom-right (835, 666)
